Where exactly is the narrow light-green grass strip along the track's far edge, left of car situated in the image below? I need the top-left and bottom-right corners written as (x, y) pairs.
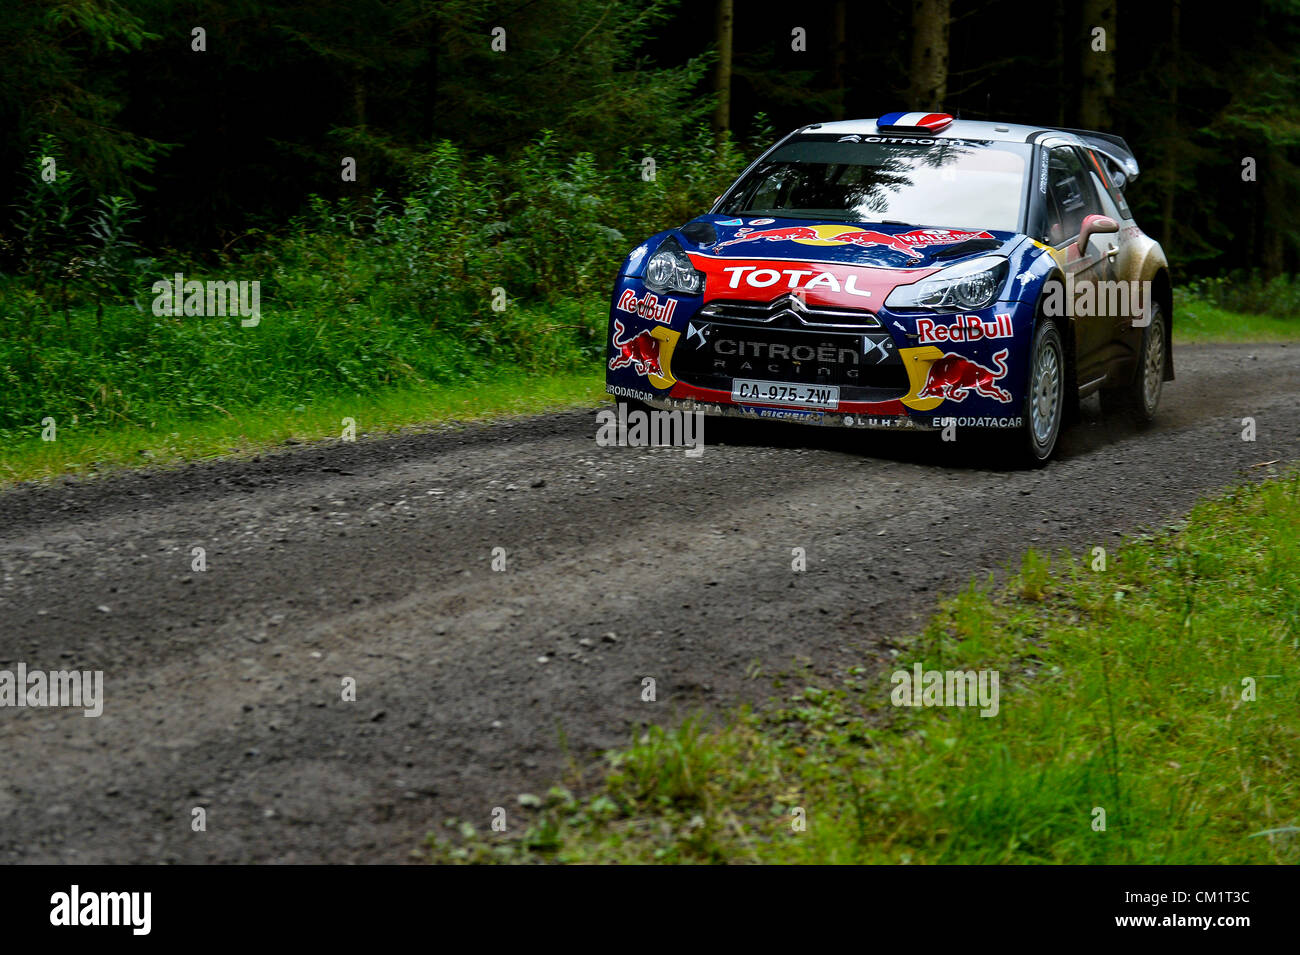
top-left (0, 372), bottom-right (605, 483)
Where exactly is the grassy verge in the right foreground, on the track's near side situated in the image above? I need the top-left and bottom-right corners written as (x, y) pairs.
top-left (429, 474), bottom-right (1300, 864)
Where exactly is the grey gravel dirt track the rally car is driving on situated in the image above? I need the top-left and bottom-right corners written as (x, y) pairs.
top-left (0, 346), bottom-right (1300, 863)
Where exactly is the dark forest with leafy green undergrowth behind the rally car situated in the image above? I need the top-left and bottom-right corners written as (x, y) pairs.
top-left (0, 0), bottom-right (1300, 452)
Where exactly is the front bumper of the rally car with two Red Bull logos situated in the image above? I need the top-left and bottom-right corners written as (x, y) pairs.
top-left (606, 270), bottom-right (1034, 431)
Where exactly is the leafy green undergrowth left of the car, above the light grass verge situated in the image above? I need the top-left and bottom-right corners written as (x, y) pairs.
top-left (0, 129), bottom-right (759, 435)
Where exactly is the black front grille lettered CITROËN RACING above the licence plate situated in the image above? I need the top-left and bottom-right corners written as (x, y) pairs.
top-left (672, 319), bottom-right (907, 401)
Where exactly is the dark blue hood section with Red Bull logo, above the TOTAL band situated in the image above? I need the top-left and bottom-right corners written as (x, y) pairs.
top-left (677, 214), bottom-right (1023, 269)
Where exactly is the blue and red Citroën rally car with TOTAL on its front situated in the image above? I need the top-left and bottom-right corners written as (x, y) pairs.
top-left (606, 113), bottom-right (1174, 464)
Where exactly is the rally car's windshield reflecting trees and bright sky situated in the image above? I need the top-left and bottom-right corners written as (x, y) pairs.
top-left (720, 135), bottom-right (1031, 233)
